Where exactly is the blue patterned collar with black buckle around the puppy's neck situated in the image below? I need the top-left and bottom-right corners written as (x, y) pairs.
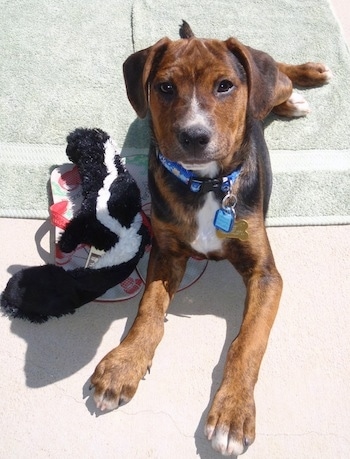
top-left (158, 151), bottom-right (241, 193)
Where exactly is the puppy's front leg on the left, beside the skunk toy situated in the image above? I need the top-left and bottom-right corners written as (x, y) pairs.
top-left (91, 241), bottom-right (187, 410)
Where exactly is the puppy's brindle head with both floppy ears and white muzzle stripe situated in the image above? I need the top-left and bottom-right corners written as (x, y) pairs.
top-left (124, 29), bottom-right (288, 173)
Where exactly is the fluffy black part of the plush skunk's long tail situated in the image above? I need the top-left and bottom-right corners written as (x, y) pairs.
top-left (0, 227), bottom-right (149, 323)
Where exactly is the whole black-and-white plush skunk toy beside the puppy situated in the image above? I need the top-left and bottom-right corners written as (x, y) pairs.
top-left (1, 129), bottom-right (150, 323)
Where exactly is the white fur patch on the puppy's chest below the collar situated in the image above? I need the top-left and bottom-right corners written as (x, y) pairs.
top-left (191, 192), bottom-right (222, 254)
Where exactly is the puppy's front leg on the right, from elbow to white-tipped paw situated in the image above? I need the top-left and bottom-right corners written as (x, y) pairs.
top-left (205, 235), bottom-right (282, 456)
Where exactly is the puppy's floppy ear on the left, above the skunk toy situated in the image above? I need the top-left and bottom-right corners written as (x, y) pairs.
top-left (123, 38), bottom-right (170, 118)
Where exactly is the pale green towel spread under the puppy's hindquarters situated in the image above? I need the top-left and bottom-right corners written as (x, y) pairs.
top-left (0, 0), bottom-right (350, 225)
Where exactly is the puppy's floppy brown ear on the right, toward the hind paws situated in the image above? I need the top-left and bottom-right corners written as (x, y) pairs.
top-left (226, 38), bottom-right (293, 120)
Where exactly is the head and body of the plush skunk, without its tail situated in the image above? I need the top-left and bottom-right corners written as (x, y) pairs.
top-left (59, 129), bottom-right (141, 253)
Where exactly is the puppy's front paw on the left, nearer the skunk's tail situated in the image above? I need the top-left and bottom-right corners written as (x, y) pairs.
top-left (91, 344), bottom-right (151, 411)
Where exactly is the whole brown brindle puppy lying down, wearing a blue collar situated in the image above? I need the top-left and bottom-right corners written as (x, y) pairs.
top-left (92, 25), bottom-right (331, 455)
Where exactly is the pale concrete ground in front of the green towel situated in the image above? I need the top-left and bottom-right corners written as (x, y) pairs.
top-left (0, 0), bottom-right (350, 459)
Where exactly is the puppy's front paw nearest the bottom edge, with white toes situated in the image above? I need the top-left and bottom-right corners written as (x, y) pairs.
top-left (205, 388), bottom-right (255, 456)
